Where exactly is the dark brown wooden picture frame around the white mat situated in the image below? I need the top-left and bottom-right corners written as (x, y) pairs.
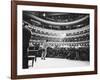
top-left (11, 0), bottom-right (97, 79)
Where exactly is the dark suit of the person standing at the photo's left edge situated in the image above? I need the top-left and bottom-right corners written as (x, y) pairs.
top-left (23, 28), bottom-right (31, 69)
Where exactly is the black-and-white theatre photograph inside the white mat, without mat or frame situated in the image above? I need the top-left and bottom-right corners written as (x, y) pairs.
top-left (22, 11), bottom-right (90, 68)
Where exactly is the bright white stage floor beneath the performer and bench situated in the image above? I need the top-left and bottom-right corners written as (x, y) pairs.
top-left (29, 57), bottom-right (90, 69)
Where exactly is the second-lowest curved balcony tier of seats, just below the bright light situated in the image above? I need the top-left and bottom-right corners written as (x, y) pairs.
top-left (31, 35), bottom-right (89, 42)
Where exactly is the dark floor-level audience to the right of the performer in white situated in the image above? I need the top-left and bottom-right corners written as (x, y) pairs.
top-left (43, 47), bottom-right (89, 61)
